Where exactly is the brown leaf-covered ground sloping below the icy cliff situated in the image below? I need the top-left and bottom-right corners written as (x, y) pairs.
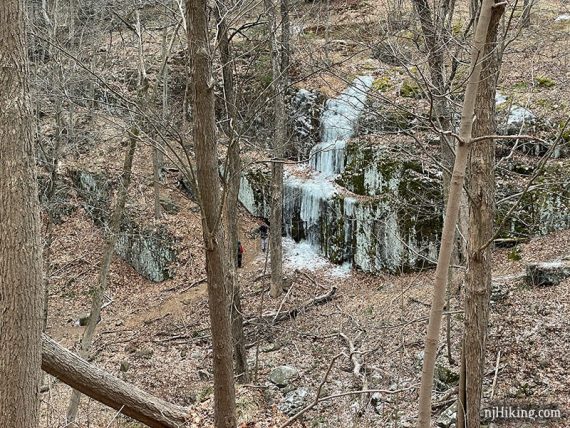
top-left (42, 199), bottom-right (570, 427)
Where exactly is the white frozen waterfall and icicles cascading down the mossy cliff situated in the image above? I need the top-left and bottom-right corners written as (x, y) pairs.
top-left (239, 76), bottom-right (438, 272)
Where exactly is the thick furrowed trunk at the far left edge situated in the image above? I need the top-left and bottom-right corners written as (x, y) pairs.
top-left (0, 0), bottom-right (43, 428)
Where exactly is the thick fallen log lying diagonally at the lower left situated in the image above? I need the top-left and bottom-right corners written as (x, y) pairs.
top-left (42, 334), bottom-right (189, 428)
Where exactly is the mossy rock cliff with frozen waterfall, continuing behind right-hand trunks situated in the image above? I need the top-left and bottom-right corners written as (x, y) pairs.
top-left (239, 77), bottom-right (570, 272)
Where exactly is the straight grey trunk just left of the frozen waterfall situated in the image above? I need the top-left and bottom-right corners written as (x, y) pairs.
top-left (264, 0), bottom-right (286, 298)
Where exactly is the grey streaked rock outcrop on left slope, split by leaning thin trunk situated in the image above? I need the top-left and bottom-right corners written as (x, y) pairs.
top-left (71, 171), bottom-right (176, 282)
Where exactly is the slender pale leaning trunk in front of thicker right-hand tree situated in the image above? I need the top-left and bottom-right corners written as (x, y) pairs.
top-left (412, 0), bottom-right (494, 428)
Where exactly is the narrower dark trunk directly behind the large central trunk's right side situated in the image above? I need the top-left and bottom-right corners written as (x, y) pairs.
top-left (216, 3), bottom-right (249, 383)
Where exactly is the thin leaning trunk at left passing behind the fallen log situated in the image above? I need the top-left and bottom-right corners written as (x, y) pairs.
top-left (67, 134), bottom-right (137, 423)
